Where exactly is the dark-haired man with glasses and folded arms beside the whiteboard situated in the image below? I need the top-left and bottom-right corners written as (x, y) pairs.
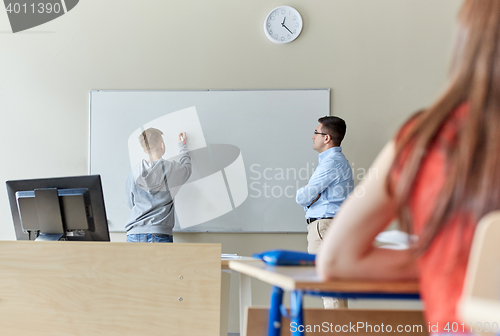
top-left (296, 116), bottom-right (354, 308)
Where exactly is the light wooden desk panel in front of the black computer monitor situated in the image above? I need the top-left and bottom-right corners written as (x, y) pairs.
top-left (0, 241), bottom-right (221, 336)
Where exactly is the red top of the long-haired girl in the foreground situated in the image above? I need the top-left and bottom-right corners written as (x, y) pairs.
top-left (400, 105), bottom-right (477, 333)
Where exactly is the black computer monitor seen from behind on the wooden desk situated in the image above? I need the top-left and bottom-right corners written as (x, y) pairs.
top-left (6, 175), bottom-right (109, 241)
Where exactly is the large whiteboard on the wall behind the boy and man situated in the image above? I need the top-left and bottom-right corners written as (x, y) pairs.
top-left (89, 89), bottom-right (330, 232)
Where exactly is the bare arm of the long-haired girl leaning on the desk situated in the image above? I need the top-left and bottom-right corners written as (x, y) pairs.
top-left (316, 141), bottom-right (417, 280)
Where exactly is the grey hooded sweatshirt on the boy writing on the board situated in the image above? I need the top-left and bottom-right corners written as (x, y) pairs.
top-left (125, 142), bottom-right (192, 235)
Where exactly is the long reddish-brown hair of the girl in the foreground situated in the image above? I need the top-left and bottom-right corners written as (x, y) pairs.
top-left (387, 0), bottom-right (500, 252)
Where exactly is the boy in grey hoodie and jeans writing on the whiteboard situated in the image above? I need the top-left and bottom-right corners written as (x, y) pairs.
top-left (125, 128), bottom-right (192, 243)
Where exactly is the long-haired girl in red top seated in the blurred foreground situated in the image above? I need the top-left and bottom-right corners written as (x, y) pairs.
top-left (317, 0), bottom-right (500, 334)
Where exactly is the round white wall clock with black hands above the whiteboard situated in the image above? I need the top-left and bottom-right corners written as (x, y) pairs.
top-left (264, 6), bottom-right (302, 44)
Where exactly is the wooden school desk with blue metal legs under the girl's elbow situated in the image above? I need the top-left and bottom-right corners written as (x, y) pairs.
top-left (229, 261), bottom-right (419, 336)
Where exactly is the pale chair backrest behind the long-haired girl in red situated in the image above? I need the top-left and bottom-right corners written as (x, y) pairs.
top-left (458, 211), bottom-right (500, 335)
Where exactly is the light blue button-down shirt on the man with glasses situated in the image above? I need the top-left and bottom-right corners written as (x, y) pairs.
top-left (296, 147), bottom-right (354, 218)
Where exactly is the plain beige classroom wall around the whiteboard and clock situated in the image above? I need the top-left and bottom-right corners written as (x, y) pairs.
top-left (0, 0), bottom-right (461, 330)
